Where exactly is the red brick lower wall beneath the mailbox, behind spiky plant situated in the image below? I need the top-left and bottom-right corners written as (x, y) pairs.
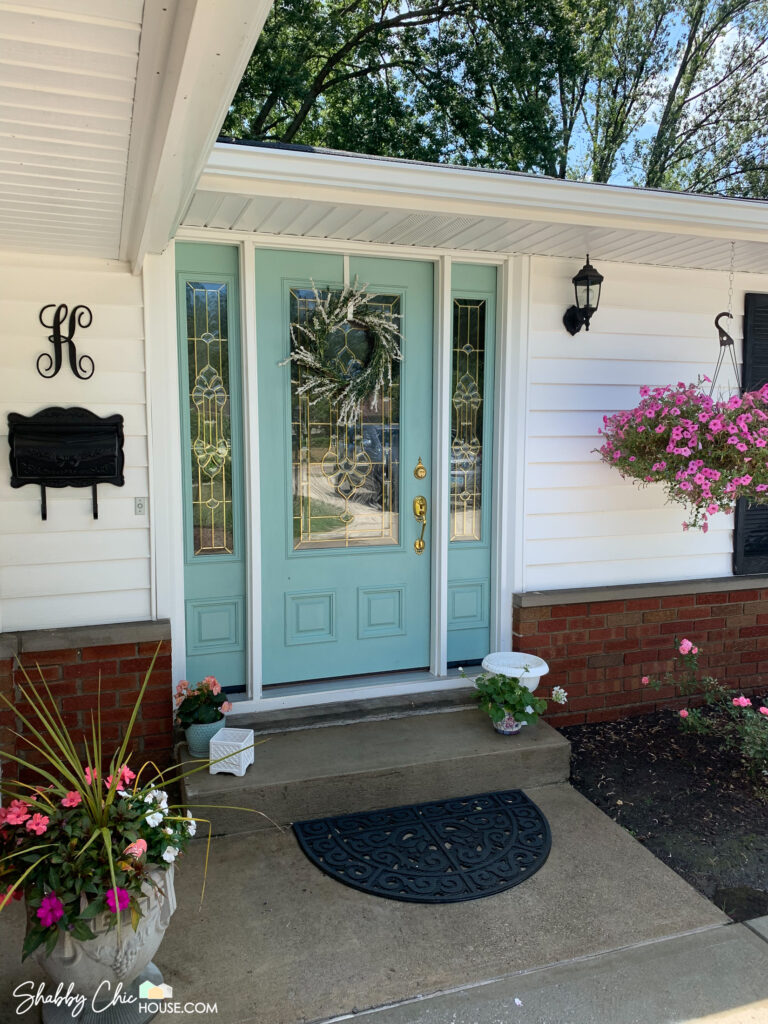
top-left (0, 640), bottom-right (173, 774)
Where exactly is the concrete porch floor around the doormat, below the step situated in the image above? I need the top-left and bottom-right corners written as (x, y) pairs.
top-left (0, 783), bottom-right (768, 1024)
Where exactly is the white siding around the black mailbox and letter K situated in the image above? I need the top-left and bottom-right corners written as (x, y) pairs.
top-left (0, 252), bottom-right (152, 631)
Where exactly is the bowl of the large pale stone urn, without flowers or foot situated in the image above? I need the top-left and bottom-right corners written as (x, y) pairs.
top-left (34, 864), bottom-right (176, 999)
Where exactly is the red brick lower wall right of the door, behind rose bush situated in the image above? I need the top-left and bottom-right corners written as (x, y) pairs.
top-left (513, 590), bottom-right (768, 726)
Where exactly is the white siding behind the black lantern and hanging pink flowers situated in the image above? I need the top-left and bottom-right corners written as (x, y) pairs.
top-left (524, 252), bottom-right (768, 591)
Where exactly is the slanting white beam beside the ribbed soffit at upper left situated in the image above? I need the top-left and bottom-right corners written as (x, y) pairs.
top-left (120, 0), bottom-right (272, 273)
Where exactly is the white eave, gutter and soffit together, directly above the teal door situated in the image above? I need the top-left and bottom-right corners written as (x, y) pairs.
top-left (189, 143), bottom-right (768, 273)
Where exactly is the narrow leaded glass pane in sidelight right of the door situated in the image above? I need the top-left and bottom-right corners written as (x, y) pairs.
top-left (451, 299), bottom-right (485, 541)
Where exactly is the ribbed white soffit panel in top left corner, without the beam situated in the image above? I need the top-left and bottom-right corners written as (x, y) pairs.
top-left (0, 0), bottom-right (143, 257)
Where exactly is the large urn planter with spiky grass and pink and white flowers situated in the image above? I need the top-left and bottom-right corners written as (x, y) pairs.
top-left (0, 648), bottom-right (259, 1013)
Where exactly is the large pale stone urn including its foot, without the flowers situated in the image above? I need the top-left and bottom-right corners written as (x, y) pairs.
top-left (34, 864), bottom-right (176, 1024)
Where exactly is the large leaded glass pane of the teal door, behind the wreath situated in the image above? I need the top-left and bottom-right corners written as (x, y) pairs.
top-left (290, 288), bottom-right (400, 550)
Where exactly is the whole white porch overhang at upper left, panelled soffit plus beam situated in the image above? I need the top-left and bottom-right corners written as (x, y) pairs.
top-left (0, 0), bottom-right (271, 271)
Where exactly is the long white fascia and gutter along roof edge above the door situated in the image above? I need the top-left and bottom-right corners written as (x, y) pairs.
top-left (198, 142), bottom-right (768, 242)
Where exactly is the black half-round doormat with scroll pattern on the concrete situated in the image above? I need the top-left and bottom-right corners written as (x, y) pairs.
top-left (293, 790), bottom-right (552, 903)
